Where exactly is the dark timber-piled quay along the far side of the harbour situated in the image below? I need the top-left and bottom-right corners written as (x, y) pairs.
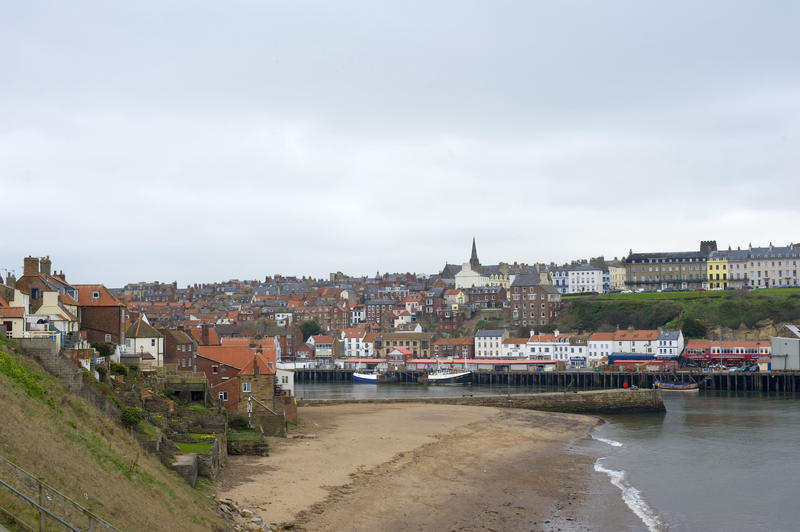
top-left (294, 368), bottom-right (800, 393)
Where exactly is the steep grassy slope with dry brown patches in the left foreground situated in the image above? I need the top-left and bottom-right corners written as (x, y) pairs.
top-left (0, 337), bottom-right (225, 531)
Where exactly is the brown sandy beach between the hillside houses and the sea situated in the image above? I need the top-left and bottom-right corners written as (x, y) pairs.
top-left (218, 404), bottom-right (642, 531)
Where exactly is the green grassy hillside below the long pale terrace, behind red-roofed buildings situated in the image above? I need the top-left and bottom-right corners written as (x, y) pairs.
top-left (558, 288), bottom-right (800, 331)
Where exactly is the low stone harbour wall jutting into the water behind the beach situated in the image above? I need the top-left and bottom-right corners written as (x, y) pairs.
top-left (297, 389), bottom-right (666, 414)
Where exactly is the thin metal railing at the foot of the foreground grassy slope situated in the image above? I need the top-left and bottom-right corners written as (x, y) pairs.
top-left (0, 456), bottom-right (117, 532)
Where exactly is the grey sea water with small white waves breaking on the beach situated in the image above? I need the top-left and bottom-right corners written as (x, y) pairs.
top-left (592, 392), bottom-right (800, 531)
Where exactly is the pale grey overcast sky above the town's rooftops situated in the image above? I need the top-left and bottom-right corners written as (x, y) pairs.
top-left (0, 0), bottom-right (800, 286)
